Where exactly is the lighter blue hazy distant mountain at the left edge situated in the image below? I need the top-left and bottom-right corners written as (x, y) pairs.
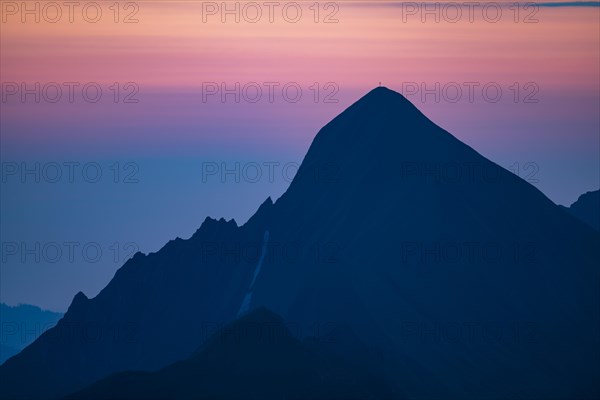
top-left (0, 303), bottom-right (63, 364)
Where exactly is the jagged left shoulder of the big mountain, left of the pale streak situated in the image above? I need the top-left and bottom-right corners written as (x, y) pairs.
top-left (0, 218), bottom-right (270, 399)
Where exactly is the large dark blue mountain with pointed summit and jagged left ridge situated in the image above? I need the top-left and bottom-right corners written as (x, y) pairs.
top-left (0, 87), bottom-right (600, 399)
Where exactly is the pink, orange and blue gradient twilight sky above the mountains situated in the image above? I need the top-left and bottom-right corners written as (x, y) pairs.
top-left (0, 1), bottom-right (600, 311)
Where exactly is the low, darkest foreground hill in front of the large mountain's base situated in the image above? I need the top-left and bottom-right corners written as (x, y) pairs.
top-left (66, 308), bottom-right (394, 400)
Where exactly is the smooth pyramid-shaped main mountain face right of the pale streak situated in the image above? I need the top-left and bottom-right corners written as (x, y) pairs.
top-left (239, 88), bottom-right (600, 398)
